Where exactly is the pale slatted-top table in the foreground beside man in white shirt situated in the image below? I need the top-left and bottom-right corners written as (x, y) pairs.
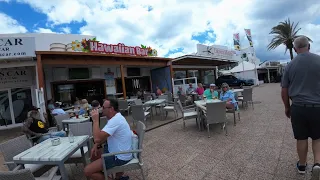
top-left (13, 136), bottom-right (89, 180)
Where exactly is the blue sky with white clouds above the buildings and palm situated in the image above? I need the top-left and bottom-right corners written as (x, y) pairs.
top-left (0, 0), bottom-right (320, 61)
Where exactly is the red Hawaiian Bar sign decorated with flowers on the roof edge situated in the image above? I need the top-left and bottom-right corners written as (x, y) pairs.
top-left (72, 38), bottom-right (157, 56)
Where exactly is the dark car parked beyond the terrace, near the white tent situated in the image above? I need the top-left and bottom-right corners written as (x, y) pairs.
top-left (216, 75), bottom-right (254, 87)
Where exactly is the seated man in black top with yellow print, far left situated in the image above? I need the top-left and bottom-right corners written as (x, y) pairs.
top-left (22, 107), bottom-right (66, 143)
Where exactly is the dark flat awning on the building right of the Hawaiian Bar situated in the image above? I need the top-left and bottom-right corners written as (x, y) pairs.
top-left (172, 55), bottom-right (237, 66)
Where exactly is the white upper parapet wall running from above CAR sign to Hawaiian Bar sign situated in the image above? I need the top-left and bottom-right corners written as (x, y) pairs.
top-left (0, 33), bottom-right (95, 51)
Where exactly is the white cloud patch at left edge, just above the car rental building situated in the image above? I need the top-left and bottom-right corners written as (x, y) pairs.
top-left (0, 13), bottom-right (27, 34)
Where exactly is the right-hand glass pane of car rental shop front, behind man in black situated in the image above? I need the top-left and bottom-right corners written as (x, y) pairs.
top-left (11, 88), bottom-right (32, 124)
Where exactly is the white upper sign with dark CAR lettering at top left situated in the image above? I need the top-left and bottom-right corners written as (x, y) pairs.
top-left (0, 37), bottom-right (35, 59)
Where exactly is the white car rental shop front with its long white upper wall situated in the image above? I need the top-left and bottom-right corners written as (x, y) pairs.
top-left (0, 34), bottom-right (93, 130)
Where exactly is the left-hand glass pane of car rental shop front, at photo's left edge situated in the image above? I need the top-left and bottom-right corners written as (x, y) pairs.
top-left (0, 90), bottom-right (12, 126)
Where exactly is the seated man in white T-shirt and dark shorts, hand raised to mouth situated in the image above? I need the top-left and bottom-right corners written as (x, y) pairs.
top-left (84, 99), bottom-right (132, 180)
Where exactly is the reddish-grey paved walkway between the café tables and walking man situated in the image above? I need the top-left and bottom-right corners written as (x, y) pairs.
top-left (0, 84), bottom-right (313, 180)
